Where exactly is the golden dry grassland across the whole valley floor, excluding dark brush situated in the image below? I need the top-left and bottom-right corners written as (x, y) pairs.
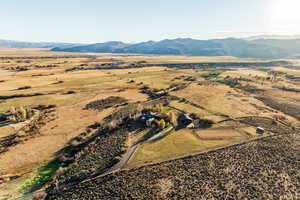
top-left (0, 48), bottom-right (300, 200)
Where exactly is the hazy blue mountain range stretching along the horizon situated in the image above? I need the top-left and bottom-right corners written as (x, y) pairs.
top-left (0, 36), bottom-right (300, 59)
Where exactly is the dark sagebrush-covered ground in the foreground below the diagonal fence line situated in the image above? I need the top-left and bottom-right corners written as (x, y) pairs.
top-left (48, 133), bottom-right (300, 199)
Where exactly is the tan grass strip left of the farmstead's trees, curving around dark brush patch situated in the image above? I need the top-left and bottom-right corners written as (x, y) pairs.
top-left (0, 89), bottom-right (147, 175)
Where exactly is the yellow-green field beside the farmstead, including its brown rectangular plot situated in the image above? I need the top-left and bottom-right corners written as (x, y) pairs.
top-left (127, 128), bottom-right (255, 168)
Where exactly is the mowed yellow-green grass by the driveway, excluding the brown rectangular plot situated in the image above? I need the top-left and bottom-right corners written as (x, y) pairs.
top-left (127, 129), bottom-right (245, 168)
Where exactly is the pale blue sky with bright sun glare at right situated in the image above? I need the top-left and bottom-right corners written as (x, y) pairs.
top-left (0, 0), bottom-right (300, 43)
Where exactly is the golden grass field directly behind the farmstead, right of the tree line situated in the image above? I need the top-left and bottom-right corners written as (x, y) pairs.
top-left (171, 84), bottom-right (263, 118)
